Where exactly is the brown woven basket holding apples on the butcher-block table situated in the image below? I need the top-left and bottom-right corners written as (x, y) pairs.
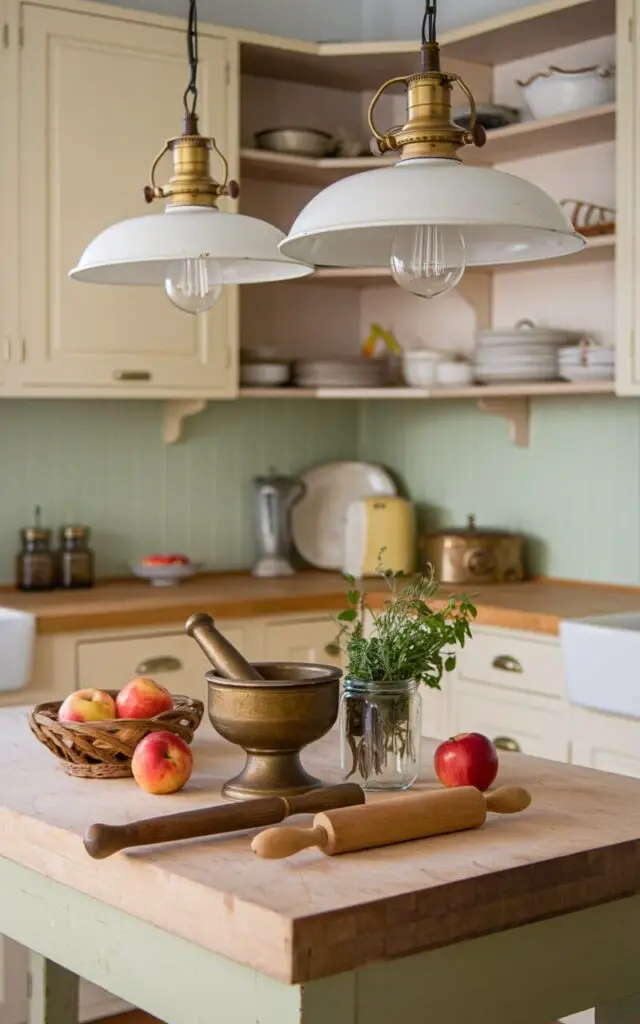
top-left (29, 690), bottom-right (205, 778)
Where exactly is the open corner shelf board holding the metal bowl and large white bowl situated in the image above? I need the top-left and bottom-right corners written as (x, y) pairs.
top-left (241, 103), bottom-right (615, 187)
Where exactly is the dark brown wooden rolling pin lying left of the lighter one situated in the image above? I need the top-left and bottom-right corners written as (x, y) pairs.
top-left (84, 782), bottom-right (365, 860)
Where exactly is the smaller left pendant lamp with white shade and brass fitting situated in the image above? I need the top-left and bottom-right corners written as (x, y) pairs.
top-left (70, 0), bottom-right (313, 313)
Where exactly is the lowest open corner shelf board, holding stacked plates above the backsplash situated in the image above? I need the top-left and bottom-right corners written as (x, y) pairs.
top-left (240, 381), bottom-right (615, 400)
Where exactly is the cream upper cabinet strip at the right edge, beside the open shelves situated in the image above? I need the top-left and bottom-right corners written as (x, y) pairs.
top-left (615, 0), bottom-right (640, 394)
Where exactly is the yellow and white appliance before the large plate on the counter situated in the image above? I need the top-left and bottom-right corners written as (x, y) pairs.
top-left (343, 497), bottom-right (416, 579)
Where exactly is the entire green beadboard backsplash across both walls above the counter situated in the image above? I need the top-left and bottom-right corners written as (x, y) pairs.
top-left (0, 397), bottom-right (640, 584)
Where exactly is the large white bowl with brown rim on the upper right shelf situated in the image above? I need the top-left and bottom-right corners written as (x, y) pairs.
top-left (518, 66), bottom-right (615, 120)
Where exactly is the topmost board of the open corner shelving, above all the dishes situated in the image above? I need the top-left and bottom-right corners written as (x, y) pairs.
top-left (239, 0), bottom-right (615, 90)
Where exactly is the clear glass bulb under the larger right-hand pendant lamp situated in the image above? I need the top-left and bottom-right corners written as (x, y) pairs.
top-left (391, 224), bottom-right (465, 299)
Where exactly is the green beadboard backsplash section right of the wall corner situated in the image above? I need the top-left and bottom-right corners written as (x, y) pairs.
top-left (358, 396), bottom-right (640, 584)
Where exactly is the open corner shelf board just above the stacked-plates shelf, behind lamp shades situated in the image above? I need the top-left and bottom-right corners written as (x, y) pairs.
top-left (291, 234), bottom-right (615, 288)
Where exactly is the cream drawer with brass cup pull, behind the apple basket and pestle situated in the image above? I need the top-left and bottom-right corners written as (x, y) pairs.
top-left (76, 623), bottom-right (252, 700)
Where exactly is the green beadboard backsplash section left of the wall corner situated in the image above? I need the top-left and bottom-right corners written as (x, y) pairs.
top-left (0, 399), bottom-right (357, 583)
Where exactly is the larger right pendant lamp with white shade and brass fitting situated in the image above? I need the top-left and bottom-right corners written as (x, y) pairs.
top-left (281, 0), bottom-right (586, 298)
